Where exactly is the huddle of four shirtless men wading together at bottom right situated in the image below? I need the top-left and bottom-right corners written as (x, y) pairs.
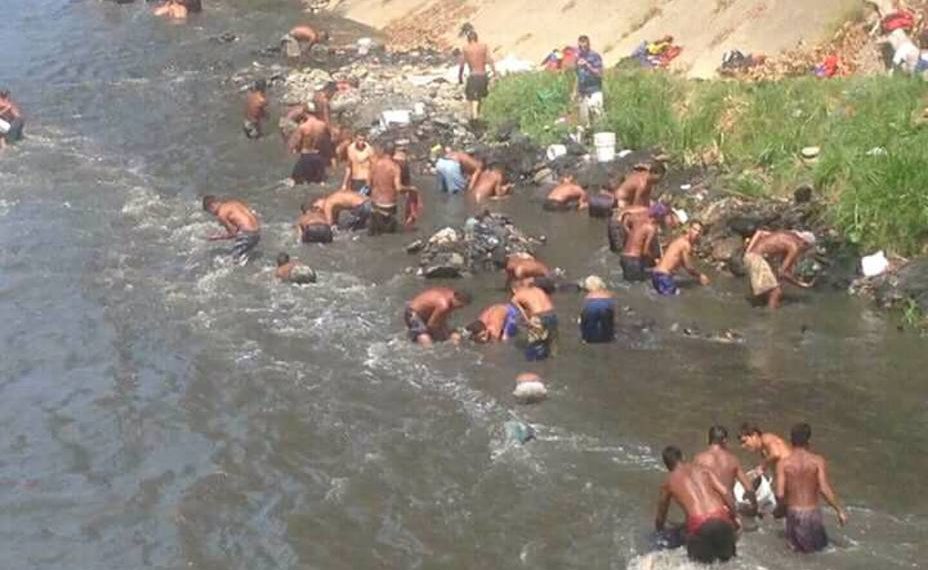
top-left (655, 423), bottom-right (847, 563)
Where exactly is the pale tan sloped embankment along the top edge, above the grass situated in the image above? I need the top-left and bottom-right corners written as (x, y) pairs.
top-left (330, 0), bottom-right (862, 77)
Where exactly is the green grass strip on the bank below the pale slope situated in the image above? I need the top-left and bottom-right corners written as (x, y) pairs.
top-left (486, 70), bottom-right (928, 255)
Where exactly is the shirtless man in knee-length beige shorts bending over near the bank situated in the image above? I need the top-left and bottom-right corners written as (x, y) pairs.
top-left (744, 230), bottom-right (815, 309)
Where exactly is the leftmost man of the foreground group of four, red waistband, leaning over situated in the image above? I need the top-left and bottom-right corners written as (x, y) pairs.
top-left (654, 446), bottom-right (741, 564)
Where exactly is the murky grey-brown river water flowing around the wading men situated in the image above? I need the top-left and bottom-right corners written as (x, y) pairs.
top-left (0, 0), bottom-right (928, 570)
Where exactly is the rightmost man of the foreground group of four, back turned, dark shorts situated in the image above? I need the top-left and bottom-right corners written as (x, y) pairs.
top-left (776, 423), bottom-right (847, 553)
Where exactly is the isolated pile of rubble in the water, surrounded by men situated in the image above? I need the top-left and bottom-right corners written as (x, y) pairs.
top-left (406, 212), bottom-right (544, 279)
